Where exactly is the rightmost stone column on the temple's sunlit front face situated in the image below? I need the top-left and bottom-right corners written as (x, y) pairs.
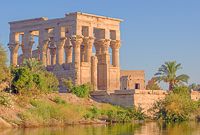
top-left (111, 40), bottom-right (121, 67)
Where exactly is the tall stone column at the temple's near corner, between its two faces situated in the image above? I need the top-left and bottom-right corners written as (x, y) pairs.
top-left (71, 35), bottom-right (83, 85)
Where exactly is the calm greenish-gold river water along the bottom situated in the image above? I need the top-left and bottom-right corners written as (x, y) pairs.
top-left (0, 122), bottom-right (200, 135)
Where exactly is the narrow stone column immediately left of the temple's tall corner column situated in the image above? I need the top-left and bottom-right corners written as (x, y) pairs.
top-left (65, 37), bottom-right (73, 64)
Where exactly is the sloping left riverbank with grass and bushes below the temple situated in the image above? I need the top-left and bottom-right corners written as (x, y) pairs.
top-left (0, 44), bottom-right (145, 127)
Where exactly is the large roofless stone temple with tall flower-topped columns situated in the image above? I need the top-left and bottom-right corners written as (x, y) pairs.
top-left (8, 12), bottom-right (122, 91)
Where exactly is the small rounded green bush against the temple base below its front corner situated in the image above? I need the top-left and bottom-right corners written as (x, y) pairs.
top-left (71, 84), bottom-right (91, 98)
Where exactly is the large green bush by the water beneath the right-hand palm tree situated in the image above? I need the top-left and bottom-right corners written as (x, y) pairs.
top-left (151, 87), bottom-right (197, 122)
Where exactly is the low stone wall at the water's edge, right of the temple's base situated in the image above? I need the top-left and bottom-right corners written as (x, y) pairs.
top-left (91, 90), bottom-right (167, 111)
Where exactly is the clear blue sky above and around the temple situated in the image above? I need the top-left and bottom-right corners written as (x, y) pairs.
top-left (0, 0), bottom-right (200, 87)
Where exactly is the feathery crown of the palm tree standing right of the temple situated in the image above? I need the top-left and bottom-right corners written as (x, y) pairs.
top-left (155, 61), bottom-right (189, 90)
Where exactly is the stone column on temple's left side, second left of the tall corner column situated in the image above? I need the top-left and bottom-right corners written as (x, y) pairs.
top-left (56, 37), bottom-right (66, 65)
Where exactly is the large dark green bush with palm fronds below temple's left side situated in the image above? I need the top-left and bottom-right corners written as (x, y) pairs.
top-left (11, 60), bottom-right (59, 95)
